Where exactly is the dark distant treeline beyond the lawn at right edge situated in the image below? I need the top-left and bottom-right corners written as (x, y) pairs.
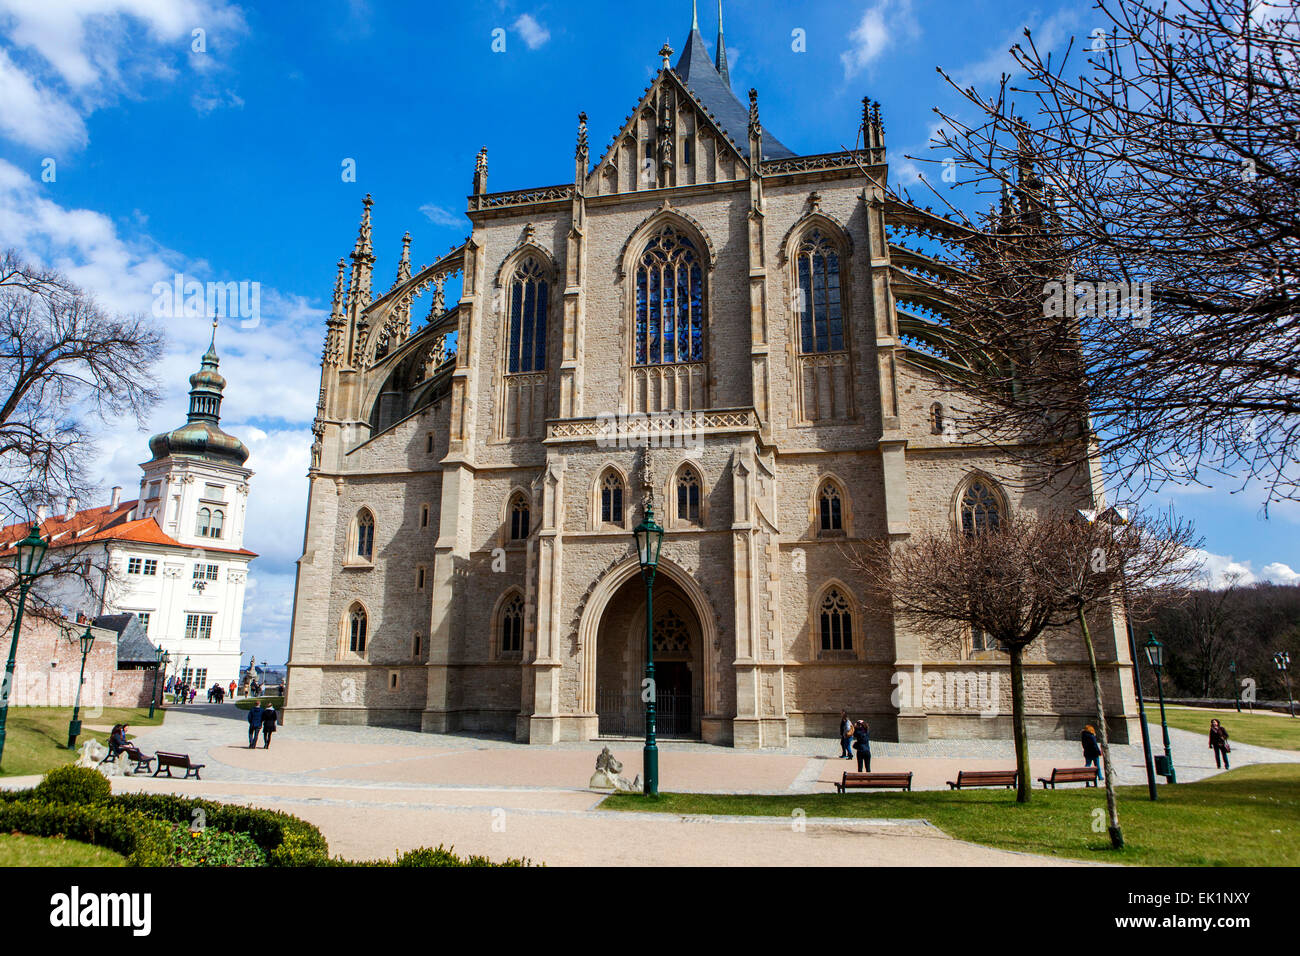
top-left (1134, 584), bottom-right (1300, 700)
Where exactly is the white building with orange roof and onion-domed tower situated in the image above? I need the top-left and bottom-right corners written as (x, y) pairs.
top-left (22, 332), bottom-right (257, 688)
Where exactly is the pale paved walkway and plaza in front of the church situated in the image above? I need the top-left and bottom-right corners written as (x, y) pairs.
top-left (7, 704), bottom-right (1300, 866)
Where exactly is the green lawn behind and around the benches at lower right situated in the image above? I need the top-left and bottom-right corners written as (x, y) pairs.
top-left (601, 763), bottom-right (1300, 866)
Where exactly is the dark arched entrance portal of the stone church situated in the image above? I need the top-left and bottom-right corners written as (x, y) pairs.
top-left (595, 574), bottom-right (703, 737)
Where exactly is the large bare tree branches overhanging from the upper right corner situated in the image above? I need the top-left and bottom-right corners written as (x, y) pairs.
top-left (922, 0), bottom-right (1300, 501)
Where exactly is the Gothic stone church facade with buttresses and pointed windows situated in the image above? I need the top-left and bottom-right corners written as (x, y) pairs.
top-left (286, 13), bottom-right (1134, 748)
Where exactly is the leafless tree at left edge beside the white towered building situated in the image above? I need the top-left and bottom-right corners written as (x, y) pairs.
top-left (0, 250), bottom-right (163, 616)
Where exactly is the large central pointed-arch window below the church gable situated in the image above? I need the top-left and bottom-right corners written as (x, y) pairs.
top-left (634, 225), bottom-right (705, 365)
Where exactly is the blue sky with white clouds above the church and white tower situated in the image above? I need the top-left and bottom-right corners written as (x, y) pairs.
top-left (0, 0), bottom-right (1300, 661)
